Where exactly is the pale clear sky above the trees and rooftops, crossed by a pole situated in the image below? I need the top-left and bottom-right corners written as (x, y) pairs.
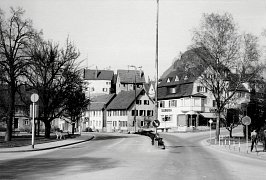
top-left (0, 0), bottom-right (266, 79)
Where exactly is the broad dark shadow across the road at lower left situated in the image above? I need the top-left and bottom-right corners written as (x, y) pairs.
top-left (0, 157), bottom-right (118, 179)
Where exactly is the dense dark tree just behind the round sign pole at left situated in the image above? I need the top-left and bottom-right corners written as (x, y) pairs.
top-left (28, 39), bottom-right (79, 138)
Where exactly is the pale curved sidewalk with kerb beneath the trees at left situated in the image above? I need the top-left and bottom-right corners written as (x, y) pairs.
top-left (0, 135), bottom-right (94, 153)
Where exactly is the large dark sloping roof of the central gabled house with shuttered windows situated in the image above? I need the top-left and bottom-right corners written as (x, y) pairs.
top-left (107, 89), bottom-right (145, 110)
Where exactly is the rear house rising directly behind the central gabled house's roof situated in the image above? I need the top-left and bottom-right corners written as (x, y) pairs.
top-left (116, 70), bottom-right (145, 94)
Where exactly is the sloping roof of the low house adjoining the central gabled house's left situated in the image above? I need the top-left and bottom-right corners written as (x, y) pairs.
top-left (88, 94), bottom-right (115, 111)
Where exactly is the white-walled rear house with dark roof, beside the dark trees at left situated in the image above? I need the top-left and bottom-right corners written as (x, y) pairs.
top-left (83, 69), bottom-right (115, 97)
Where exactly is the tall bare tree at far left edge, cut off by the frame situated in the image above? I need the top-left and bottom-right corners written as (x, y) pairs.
top-left (0, 8), bottom-right (38, 141)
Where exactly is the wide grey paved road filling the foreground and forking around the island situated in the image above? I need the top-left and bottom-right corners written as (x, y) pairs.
top-left (0, 133), bottom-right (265, 180)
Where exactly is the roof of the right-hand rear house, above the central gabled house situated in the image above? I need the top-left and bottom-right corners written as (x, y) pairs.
top-left (117, 69), bottom-right (145, 84)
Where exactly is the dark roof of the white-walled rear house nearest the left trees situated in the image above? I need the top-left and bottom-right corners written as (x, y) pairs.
top-left (84, 69), bottom-right (114, 81)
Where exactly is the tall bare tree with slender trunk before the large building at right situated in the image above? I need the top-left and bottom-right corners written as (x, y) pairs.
top-left (192, 13), bottom-right (261, 139)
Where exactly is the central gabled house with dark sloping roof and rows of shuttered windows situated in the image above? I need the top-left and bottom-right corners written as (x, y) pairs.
top-left (107, 89), bottom-right (154, 132)
